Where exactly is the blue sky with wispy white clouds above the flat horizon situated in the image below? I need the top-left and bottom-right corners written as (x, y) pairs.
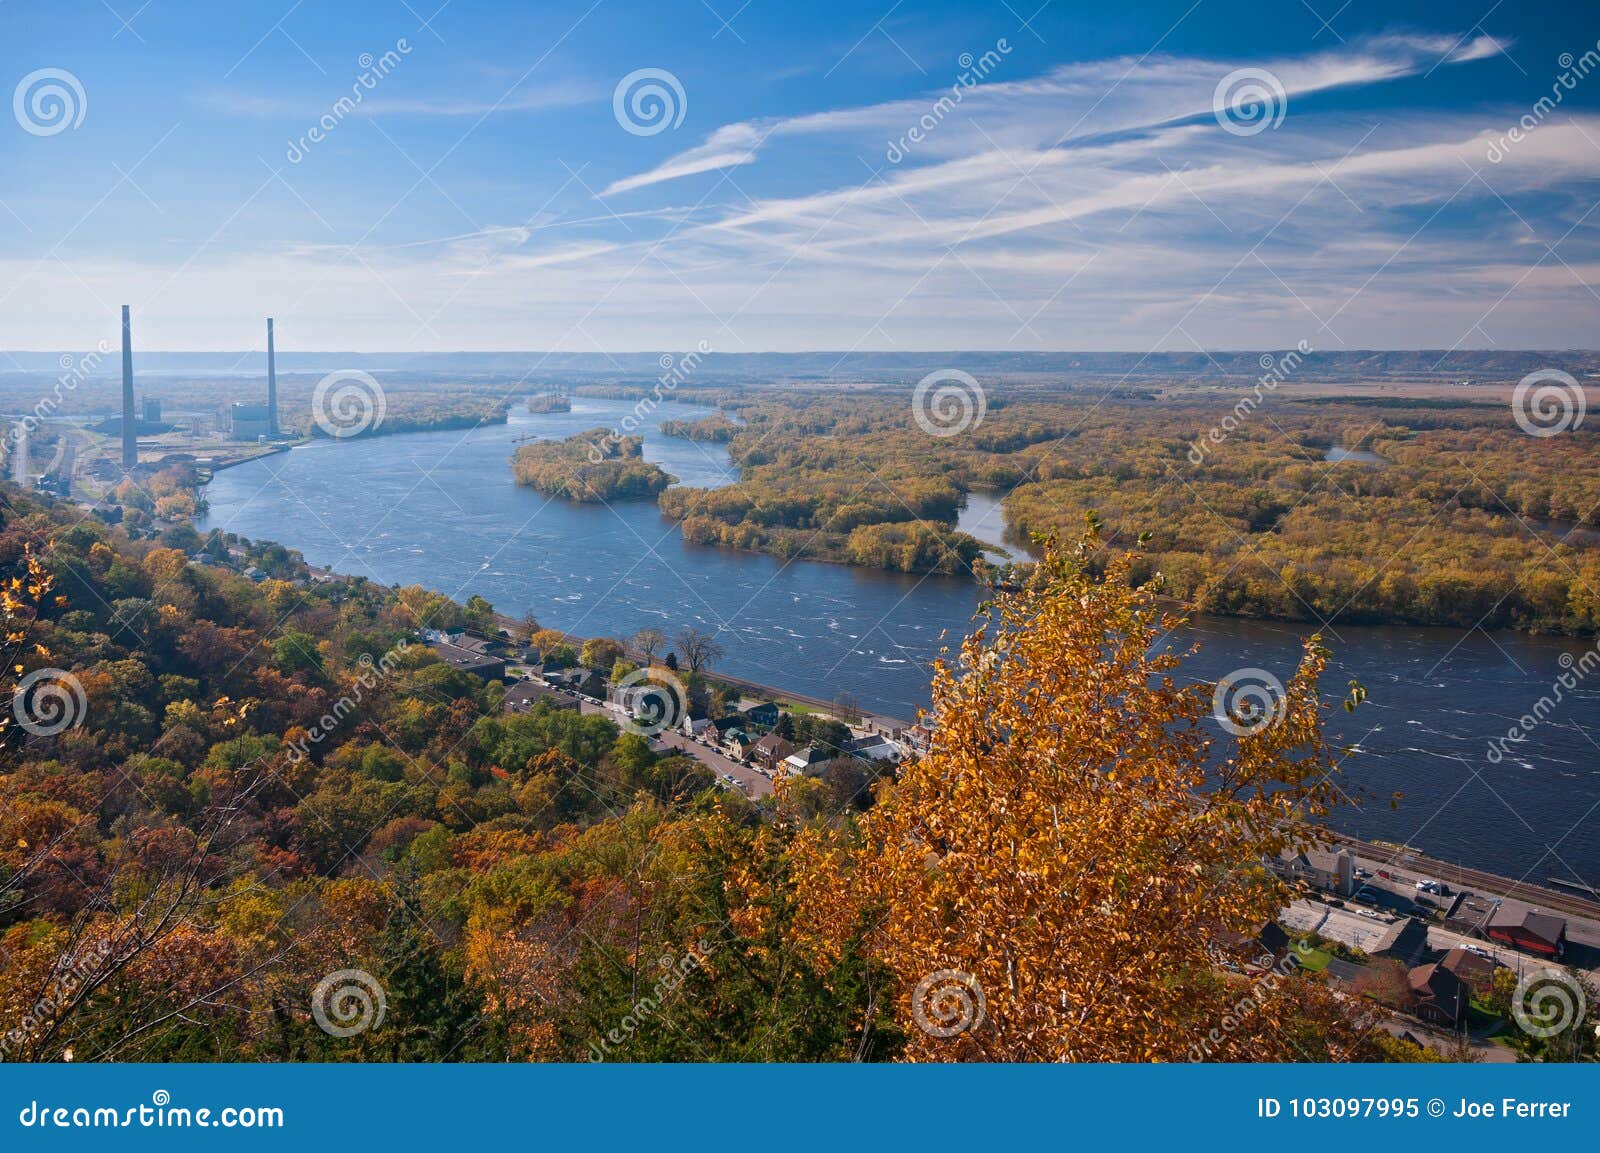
top-left (0, 0), bottom-right (1600, 352)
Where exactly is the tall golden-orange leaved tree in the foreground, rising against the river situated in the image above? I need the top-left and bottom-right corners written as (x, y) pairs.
top-left (795, 534), bottom-right (1373, 1060)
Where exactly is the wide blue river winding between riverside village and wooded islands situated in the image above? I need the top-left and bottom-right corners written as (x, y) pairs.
top-left (200, 398), bottom-right (1600, 888)
